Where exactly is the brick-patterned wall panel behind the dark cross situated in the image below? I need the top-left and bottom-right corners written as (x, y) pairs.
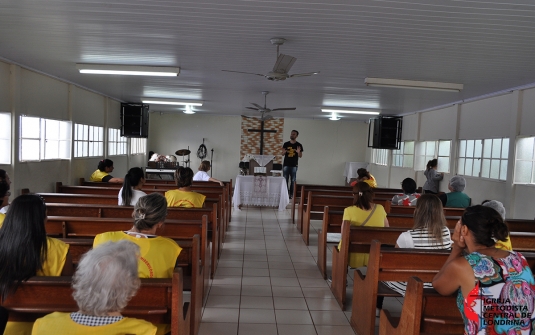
top-left (240, 116), bottom-right (284, 164)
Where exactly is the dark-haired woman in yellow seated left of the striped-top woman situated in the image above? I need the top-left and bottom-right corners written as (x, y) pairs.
top-left (338, 182), bottom-right (388, 268)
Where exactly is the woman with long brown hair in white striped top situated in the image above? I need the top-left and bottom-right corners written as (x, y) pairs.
top-left (377, 194), bottom-right (452, 302)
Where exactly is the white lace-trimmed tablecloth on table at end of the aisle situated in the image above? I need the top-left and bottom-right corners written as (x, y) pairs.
top-left (232, 176), bottom-right (290, 211)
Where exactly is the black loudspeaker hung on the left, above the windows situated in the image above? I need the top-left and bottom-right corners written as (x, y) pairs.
top-left (121, 103), bottom-right (149, 137)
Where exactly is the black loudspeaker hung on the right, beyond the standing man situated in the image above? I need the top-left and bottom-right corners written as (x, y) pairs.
top-left (368, 116), bottom-right (403, 149)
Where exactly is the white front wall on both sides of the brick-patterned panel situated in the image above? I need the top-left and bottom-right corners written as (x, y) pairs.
top-left (148, 113), bottom-right (367, 185)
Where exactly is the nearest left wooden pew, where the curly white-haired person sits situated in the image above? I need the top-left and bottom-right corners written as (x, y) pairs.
top-left (2, 268), bottom-right (191, 335)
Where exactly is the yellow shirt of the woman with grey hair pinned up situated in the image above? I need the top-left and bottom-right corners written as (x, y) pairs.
top-left (93, 231), bottom-right (182, 278)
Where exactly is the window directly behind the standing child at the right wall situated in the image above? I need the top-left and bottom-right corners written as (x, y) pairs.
top-left (415, 140), bottom-right (451, 172)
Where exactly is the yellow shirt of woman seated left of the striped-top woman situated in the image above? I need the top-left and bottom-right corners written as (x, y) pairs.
top-left (338, 204), bottom-right (386, 268)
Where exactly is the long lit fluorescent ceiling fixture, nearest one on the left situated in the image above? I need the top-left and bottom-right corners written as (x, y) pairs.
top-left (76, 64), bottom-right (180, 77)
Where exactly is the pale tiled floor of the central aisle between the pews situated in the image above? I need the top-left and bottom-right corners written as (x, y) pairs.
top-left (199, 207), bottom-right (401, 335)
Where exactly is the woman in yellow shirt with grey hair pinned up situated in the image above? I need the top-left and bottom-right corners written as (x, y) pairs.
top-left (93, 193), bottom-right (182, 278)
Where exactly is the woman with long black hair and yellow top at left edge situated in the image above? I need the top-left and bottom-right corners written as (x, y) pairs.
top-left (0, 194), bottom-right (73, 334)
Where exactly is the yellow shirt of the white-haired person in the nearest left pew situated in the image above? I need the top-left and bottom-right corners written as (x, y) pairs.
top-left (32, 312), bottom-right (156, 335)
